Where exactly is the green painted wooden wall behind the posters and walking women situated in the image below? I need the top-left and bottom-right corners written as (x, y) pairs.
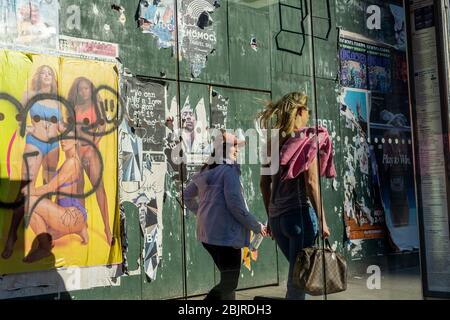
top-left (18, 0), bottom-right (414, 299)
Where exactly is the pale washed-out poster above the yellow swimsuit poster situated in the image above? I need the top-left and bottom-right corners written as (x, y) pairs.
top-left (15, 0), bottom-right (59, 49)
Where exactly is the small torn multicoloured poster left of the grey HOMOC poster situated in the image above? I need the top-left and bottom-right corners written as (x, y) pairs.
top-left (138, 0), bottom-right (175, 48)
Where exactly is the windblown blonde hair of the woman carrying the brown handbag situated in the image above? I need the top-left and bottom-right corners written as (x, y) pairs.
top-left (257, 92), bottom-right (308, 135)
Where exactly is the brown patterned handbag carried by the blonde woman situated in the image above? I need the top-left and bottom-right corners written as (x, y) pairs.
top-left (293, 237), bottom-right (347, 296)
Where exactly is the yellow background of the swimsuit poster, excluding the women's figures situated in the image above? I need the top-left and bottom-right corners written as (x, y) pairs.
top-left (0, 50), bottom-right (122, 274)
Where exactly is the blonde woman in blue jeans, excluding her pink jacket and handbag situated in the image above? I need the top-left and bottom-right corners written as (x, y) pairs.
top-left (258, 92), bottom-right (330, 300)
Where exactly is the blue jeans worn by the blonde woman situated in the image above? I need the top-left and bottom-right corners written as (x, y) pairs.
top-left (269, 207), bottom-right (316, 300)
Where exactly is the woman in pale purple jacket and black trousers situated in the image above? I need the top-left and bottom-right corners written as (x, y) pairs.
top-left (184, 132), bottom-right (266, 300)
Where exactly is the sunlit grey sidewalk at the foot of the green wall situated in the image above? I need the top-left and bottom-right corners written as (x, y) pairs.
top-left (188, 268), bottom-right (422, 300)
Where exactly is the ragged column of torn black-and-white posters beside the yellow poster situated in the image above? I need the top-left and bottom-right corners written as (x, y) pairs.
top-left (119, 78), bottom-right (167, 280)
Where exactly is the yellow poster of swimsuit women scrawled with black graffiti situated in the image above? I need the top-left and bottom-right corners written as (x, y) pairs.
top-left (0, 50), bottom-right (122, 274)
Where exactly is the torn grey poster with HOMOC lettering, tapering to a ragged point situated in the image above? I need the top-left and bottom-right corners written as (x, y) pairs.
top-left (178, 0), bottom-right (220, 78)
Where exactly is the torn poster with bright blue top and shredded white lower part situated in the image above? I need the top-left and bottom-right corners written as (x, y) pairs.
top-left (339, 88), bottom-right (386, 240)
